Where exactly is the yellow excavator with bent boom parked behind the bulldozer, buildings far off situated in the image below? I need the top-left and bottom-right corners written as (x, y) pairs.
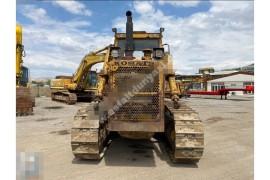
top-left (51, 46), bottom-right (110, 104)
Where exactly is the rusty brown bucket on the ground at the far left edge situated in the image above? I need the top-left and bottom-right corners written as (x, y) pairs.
top-left (16, 87), bottom-right (33, 116)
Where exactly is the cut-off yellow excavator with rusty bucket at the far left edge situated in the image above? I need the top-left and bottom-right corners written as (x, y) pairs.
top-left (16, 25), bottom-right (35, 116)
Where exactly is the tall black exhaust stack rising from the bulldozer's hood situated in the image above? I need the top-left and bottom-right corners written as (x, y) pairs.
top-left (125, 11), bottom-right (134, 60)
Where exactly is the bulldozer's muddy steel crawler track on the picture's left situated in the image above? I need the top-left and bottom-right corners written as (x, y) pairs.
top-left (71, 103), bottom-right (109, 160)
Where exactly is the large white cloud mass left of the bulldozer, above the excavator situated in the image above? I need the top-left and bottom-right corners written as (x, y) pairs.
top-left (18, 5), bottom-right (113, 78)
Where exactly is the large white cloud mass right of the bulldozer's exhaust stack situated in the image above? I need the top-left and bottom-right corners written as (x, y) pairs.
top-left (113, 1), bottom-right (254, 74)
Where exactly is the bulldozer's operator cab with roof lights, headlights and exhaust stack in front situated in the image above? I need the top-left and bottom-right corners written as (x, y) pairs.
top-left (111, 11), bottom-right (164, 60)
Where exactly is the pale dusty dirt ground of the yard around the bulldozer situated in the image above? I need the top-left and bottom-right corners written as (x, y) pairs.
top-left (16, 95), bottom-right (254, 180)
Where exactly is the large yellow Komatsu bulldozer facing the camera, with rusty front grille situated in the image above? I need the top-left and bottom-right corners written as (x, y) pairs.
top-left (71, 11), bottom-right (204, 162)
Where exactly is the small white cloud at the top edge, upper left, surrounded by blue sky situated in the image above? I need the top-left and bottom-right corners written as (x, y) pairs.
top-left (52, 1), bottom-right (92, 16)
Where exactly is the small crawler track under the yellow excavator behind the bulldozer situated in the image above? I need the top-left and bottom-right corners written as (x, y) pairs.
top-left (51, 91), bottom-right (77, 105)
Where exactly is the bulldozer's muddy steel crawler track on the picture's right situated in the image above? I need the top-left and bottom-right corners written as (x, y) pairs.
top-left (165, 102), bottom-right (204, 163)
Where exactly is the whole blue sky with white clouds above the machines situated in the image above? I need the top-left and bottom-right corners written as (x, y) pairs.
top-left (16, 0), bottom-right (254, 78)
